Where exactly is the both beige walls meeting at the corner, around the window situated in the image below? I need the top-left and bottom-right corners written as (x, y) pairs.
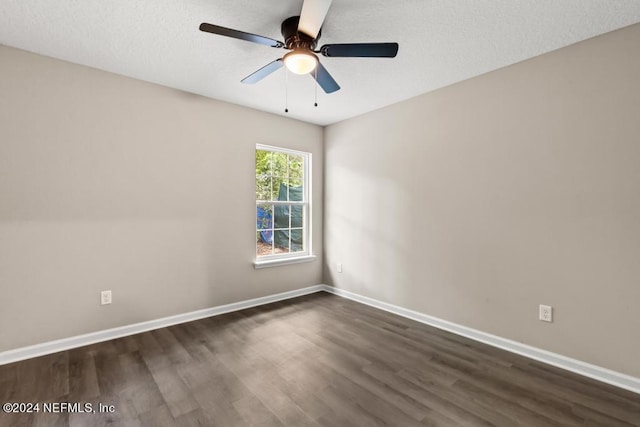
top-left (0, 25), bottom-right (640, 382)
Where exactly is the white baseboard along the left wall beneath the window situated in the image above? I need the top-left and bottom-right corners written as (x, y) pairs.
top-left (0, 285), bottom-right (327, 365)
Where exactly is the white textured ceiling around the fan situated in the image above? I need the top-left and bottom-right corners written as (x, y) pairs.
top-left (0, 0), bottom-right (640, 125)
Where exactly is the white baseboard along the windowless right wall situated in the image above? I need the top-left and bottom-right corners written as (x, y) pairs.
top-left (323, 285), bottom-right (640, 394)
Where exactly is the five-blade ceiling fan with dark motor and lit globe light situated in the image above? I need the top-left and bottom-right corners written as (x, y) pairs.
top-left (200, 0), bottom-right (398, 93)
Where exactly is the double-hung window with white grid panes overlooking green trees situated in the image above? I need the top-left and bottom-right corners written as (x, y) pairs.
top-left (256, 145), bottom-right (312, 267)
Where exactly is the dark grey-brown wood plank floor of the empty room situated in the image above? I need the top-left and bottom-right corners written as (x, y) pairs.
top-left (0, 293), bottom-right (640, 426)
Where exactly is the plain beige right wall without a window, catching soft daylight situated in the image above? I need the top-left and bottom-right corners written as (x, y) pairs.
top-left (324, 25), bottom-right (640, 376)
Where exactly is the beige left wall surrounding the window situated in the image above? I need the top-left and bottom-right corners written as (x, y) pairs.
top-left (0, 46), bottom-right (323, 351)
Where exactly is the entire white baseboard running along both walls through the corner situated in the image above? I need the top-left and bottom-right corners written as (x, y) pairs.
top-left (0, 285), bottom-right (640, 394)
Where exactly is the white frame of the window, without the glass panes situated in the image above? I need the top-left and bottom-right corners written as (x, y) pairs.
top-left (253, 144), bottom-right (316, 269)
